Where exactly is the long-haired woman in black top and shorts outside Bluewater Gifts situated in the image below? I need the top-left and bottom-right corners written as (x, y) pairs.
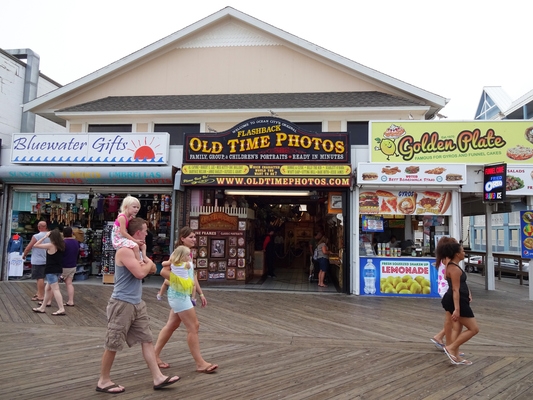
top-left (32, 229), bottom-right (66, 316)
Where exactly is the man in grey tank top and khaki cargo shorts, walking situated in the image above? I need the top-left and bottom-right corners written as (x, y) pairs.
top-left (96, 218), bottom-right (180, 394)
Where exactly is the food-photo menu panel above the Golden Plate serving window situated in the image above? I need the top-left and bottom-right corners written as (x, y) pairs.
top-left (359, 190), bottom-right (452, 215)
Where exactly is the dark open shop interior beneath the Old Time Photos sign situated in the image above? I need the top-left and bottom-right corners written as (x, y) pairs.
top-left (193, 189), bottom-right (346, 291)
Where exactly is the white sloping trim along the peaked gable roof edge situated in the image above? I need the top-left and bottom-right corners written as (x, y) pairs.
top-left (24, 7), bottom-right (448, 117)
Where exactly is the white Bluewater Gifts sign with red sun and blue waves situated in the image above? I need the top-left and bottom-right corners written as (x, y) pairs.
top-left (11, 133), bottom-right (169, 165)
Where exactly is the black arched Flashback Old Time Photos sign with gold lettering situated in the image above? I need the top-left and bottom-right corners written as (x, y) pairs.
top-left (184, 117), bottom-right (350, 164)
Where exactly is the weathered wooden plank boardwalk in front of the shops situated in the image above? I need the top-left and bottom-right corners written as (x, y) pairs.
top-left (0, 274), bottom-right (533, 400)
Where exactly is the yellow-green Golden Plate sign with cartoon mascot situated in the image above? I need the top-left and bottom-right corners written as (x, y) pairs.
top-left (369, 121), bottom-right (533, 165)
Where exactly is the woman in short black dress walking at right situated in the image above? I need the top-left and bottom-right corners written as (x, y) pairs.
top-left (439, 242), bottom-right (479, 365)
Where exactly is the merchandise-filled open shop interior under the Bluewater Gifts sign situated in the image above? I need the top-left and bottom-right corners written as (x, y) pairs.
top-left (9, 188), bottom-right (172, 283)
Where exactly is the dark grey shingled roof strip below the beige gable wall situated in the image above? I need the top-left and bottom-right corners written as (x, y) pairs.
top-left (57, 92), bottom-right (424, 114)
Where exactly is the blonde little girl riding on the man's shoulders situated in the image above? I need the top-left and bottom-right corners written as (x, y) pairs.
top-left (111, 196), bottom-right (147, 264)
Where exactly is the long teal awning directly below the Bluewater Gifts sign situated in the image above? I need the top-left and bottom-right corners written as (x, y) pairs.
top-left (0, 165), bottom-right (177, 186)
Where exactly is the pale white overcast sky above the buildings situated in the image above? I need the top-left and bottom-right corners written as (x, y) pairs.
top-left (0, 0), bottom-right (533, 120)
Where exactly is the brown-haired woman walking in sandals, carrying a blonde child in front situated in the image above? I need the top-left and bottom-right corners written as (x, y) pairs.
top-left (155, 226), bottom-right (218, 374)
